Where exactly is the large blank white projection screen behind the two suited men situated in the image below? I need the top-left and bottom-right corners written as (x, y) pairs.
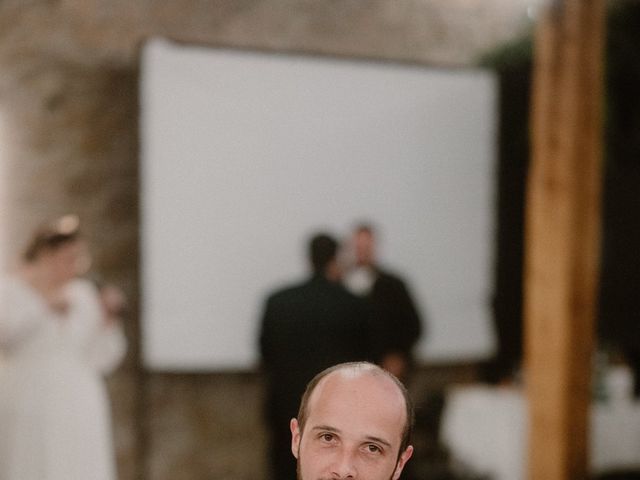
top-left (141, 40), bottom-right (497, 372)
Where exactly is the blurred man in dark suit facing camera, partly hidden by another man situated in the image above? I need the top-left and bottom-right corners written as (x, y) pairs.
top-left (345, 224), bottom-right (423, 382)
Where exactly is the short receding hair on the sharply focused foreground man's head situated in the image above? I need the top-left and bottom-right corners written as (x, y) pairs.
top-left (297, 362), bottom-right (415, 456)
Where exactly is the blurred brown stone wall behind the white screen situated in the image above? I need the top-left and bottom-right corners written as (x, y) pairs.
top-left (0, 0), bottom-right (535, 480)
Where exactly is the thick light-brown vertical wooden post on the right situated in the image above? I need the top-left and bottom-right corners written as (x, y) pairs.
top-left (524, 0), bottom-right (605, 480)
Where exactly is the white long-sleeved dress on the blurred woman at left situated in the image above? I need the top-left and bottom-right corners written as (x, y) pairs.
top-left (0, 278), bottom-right (126, 480)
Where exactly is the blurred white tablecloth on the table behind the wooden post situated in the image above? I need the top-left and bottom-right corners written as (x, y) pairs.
top-left (441, 385), bottom-right (640, 480)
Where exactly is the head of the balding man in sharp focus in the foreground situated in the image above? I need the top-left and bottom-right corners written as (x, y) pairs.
top-left (291, 362), bottom-right (413, 480)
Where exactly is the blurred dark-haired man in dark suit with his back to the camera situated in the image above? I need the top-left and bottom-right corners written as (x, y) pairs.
top-left (260, 234), bottom-right (372, 480)
